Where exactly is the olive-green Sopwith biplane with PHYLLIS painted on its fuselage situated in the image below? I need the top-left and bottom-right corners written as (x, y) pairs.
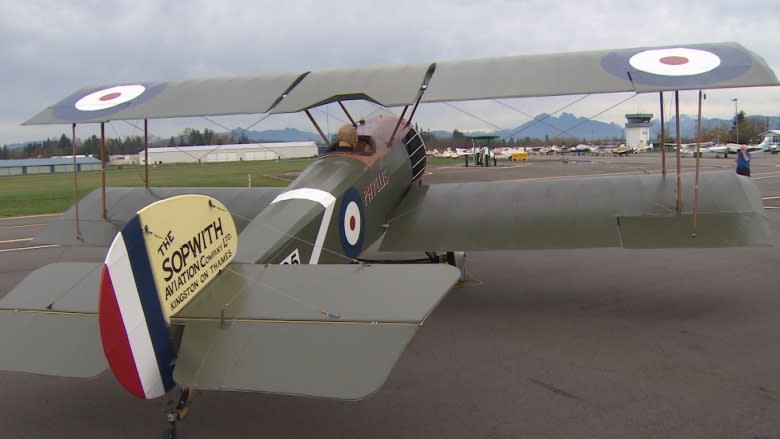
top-left (0, 43), bottom-right (778, 430)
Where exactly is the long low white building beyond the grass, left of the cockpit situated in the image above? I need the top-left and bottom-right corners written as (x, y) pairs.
top-left (138, 141), bottom-right (317, 164)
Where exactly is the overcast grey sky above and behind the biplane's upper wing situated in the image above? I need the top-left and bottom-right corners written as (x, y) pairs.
top-left (0, 0), bottom-right (780, 145)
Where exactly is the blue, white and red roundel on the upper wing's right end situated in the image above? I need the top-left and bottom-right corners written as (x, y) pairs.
top-left (601, 44), bottom-right (752, 88)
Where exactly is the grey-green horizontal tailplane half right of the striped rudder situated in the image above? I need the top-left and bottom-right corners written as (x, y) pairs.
top-left (172, 264), bottom-right (460, 399)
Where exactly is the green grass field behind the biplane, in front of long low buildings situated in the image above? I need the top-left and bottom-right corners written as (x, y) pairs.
top-left (0, 159), bottom-right (312, 217)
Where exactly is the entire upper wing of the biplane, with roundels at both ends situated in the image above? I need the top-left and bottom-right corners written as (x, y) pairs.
top-left (25, 43), bottom-right (779, 124)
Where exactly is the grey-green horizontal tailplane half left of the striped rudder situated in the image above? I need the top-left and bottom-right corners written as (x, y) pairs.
top-left (0, 263), bottom-right (108, 378)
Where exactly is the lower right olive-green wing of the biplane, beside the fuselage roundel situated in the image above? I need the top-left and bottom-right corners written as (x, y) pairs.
top-left (380, 172), bottom-right (772, 251)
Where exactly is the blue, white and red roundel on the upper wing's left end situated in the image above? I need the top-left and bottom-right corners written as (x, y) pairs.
top-left (52, 83), bottom-right (166, 122)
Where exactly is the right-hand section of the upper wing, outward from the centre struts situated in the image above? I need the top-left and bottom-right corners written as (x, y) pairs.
top-left (422, 43), bottom-right (778, 102)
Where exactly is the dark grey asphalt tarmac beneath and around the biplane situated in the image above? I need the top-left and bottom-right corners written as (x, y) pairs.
top-left (0, 154), bottom-right (780, 439)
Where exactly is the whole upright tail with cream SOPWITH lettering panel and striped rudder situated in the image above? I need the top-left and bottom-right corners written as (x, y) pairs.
top-left (98, 195), bottom-right (238, 398)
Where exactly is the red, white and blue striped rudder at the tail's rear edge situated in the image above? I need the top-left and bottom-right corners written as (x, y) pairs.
top-left (98, 215), bottom-right (175, 399)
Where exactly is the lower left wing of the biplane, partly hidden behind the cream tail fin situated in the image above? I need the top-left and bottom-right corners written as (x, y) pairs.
top-left (34, 187), bottom-right (284, 246)
